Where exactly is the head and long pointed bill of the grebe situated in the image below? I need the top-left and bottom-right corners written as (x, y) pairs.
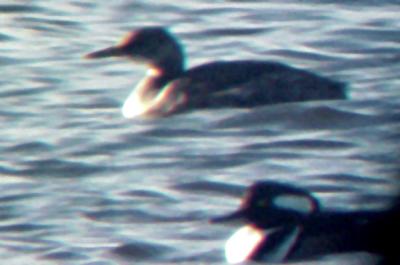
top-left (85, 27), bottom-right (183, 68)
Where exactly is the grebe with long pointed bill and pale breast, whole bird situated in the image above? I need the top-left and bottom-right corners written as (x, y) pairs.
top-left (84, 26), bottom-right (346, 118)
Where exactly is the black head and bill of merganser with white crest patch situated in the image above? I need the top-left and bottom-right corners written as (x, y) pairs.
top-left (211, 181), bottom-right (319, 229)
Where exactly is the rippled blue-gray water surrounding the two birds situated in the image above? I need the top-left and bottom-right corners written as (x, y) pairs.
top-left (0, 0), bottom-right (400, 265)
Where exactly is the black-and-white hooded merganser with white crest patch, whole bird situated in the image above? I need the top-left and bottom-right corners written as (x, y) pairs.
top-left (210, 181), bottom-right (400, 265)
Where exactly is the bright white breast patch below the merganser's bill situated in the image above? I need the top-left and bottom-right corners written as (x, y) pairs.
top-left (225, 225), bottom-right (265, 264)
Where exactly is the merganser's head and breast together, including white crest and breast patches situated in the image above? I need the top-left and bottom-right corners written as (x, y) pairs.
top-left (210, 181), bottom-right (319, 264)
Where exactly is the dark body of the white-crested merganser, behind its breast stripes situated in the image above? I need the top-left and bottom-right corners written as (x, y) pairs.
top-left (287, 208), bottom-right (400, 265)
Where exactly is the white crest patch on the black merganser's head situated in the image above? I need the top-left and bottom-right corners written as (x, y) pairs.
top-left (272, 195), bottom-right (315, 215)
